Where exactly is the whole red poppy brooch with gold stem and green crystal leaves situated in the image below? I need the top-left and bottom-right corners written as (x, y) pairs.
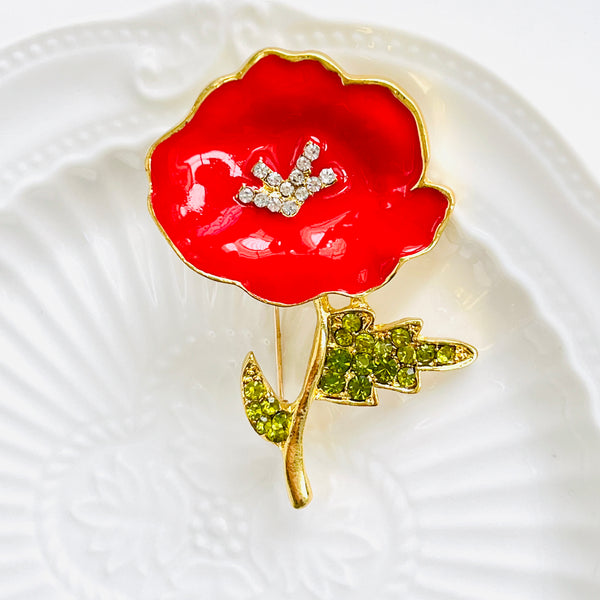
top-left (146, 49), bottom-right (477, 508)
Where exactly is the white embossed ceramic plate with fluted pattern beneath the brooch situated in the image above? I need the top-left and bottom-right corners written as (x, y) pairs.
top-left (0, 3), bottom-right (600, 600)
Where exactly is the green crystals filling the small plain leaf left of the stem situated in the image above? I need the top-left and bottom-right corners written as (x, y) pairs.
top-left (242, 366), bottom-right (291, 444)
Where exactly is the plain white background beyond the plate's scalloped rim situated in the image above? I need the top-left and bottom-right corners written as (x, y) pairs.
top-left (0, 0), bottom-right (600, 181)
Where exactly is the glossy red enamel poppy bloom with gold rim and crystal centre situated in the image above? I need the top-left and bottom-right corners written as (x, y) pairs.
top-left (147, 50), bottom-right (452, 305)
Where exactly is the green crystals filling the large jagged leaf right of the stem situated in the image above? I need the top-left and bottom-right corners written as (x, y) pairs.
top-left (319, 310), bottom-right (457, 403)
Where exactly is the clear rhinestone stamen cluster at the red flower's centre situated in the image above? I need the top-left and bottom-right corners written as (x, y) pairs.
top-left (237, 141), bottom-right (337, 217)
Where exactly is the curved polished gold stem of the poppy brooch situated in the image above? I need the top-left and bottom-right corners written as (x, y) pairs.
top-left (283, 298), bottom-right (329, 508)
